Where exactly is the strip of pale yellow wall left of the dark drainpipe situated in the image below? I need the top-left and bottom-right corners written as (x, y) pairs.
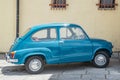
top-left (0, 0), bottom-right (16, 52)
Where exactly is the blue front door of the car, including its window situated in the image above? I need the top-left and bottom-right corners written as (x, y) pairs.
top-left (59, 27), bottom-right (92, 63)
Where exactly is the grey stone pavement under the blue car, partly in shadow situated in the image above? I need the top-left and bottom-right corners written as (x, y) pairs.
top-left (0, 53), bottom-right (120, 80)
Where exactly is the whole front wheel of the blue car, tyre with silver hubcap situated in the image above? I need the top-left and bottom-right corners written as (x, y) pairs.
top-left (93, 51), bottom-right (110, 68)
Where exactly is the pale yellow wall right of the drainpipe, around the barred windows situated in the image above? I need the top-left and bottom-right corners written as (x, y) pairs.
top-left (20, 0), bottom-right (120, 50)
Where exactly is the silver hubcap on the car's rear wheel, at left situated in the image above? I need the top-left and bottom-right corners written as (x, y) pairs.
top-left (29, 59), bottom-right (42, 71)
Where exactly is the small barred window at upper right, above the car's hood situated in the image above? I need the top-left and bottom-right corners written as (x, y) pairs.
top-left (97, 0), bottom-right (118, 9)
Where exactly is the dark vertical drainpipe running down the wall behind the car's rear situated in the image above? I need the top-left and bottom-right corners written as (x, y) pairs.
top-left (16, 0), bottom-right (19, 38)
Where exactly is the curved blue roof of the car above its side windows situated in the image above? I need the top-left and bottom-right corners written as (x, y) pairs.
top-left (31, 23), bottom-right (78, 29)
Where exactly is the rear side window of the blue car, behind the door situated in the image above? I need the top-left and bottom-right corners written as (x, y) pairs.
top-left (32, 28), bottom-right (57, 41)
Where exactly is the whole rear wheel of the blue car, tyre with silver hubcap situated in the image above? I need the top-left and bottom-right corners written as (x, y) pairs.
top-left (25, 56), bottom-right (44, 74)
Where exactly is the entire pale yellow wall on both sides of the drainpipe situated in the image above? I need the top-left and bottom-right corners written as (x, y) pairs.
top-left (0, 0), bottom-right (120, 51)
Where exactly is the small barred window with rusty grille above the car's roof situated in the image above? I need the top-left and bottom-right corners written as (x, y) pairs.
top-left (50, 0), bottom-right (68, 8)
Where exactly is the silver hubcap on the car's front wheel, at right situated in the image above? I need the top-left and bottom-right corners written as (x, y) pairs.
top-left (95, 54), bottom-right (106, 66)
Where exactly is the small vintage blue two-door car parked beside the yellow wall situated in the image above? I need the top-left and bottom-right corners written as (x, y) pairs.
top-left (6, 23), bottom-right (113, 74)
